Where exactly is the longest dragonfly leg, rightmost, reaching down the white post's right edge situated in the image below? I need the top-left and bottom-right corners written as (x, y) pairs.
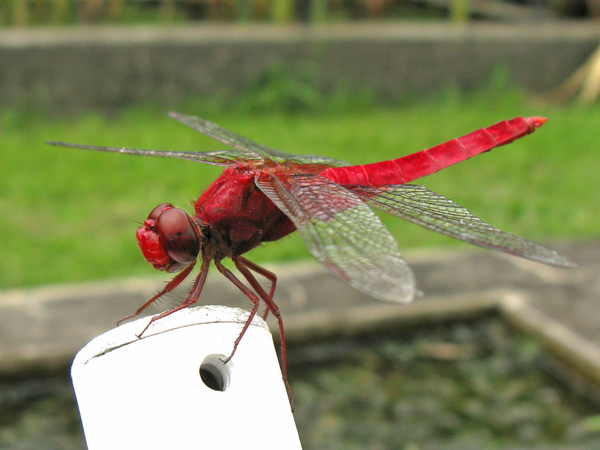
top-left (232, 256), bottom-right (294, 411)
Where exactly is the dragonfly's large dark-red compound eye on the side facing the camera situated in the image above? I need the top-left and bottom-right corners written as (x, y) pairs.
top-left (156, 209), bottom-right (200, 264)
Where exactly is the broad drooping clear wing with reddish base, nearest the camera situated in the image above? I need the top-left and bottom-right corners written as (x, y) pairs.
top-left (255, 175), bottom-right (415, 302)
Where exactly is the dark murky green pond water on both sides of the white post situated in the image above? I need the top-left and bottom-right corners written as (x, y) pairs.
top-left (0, 318), bottom-right (600, 450)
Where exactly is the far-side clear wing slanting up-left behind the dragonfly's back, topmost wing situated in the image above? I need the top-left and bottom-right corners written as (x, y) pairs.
top-left (169, 112), bottom-right (349, 167)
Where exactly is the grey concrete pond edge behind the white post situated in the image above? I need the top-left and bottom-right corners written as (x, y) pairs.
top-left (0, 244), bottom-right (600, 403)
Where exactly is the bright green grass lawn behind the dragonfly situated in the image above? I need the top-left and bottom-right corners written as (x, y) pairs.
top-left (0, 90), bottom-right (600, 288)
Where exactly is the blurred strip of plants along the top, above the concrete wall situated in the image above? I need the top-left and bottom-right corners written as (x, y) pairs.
top-left (0, 0), bottom-right (600, 26)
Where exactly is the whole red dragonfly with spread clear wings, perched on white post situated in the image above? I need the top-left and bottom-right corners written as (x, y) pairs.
top-left (50, 113), bottom-right (573, 399)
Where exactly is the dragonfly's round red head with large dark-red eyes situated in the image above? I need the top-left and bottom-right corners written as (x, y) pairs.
top-left (137, 203), bottom-right (200, 272)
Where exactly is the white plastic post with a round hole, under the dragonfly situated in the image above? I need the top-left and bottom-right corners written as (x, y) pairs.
top-left (71, 306), bottom-right (301, 450)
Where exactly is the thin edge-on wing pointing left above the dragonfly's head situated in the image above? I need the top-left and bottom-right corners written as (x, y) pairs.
top-left (46, 141), bottom-right (248, 166)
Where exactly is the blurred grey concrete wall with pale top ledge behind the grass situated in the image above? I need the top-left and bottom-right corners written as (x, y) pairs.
top-left (0, 23), bottom-right (600, 113)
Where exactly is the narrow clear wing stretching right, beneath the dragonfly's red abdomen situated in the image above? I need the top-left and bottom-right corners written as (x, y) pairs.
top-left (348, 184), bottom-right (575, 267)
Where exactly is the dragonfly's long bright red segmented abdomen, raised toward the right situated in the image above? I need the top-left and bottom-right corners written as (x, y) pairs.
top-left (321, 117), bottom-right (546, 185)
